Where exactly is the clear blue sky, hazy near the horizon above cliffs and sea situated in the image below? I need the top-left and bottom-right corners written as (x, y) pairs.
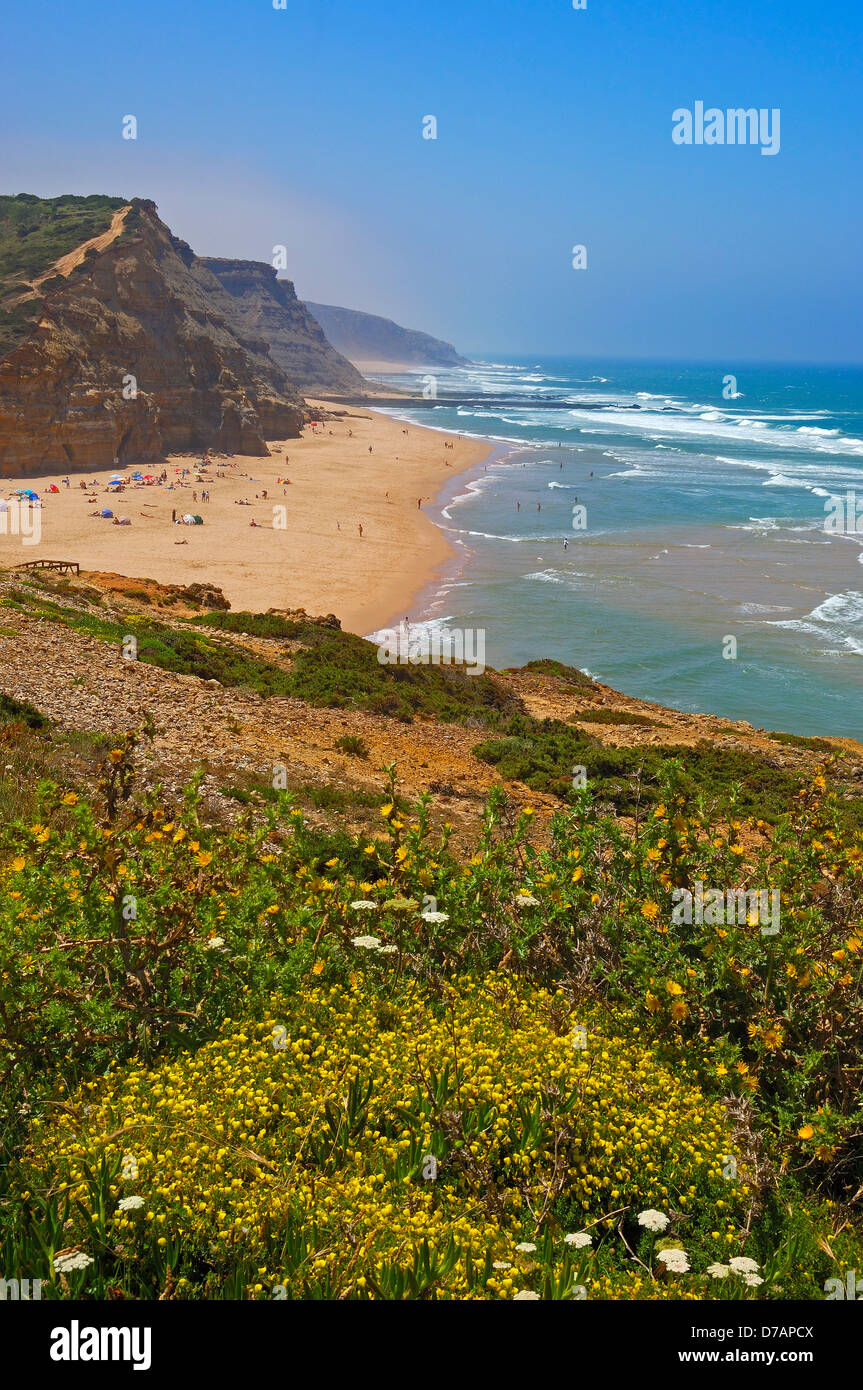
top-left (0, 0), bottom-right (863, 370)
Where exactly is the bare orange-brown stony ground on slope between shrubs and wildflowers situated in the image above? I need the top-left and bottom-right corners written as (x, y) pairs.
top-left (0, 571), bottom-right (863, 838)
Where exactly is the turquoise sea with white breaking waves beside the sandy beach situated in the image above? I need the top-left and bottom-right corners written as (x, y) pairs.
top-left (372, 359), bottom-right (863, 738)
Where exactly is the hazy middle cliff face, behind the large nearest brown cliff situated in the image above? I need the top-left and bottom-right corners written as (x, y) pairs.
top-left (197, 256), bottom-right (368, 395)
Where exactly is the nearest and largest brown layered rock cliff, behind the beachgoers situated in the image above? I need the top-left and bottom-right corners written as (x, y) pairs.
top-left (0, 200), bottom-right (304, 477)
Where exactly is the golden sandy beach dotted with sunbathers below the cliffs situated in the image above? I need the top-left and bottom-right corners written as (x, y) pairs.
top-left (0, 402), bottom-right (491, 635)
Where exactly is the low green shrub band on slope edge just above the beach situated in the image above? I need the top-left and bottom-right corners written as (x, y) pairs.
top-left (6, 580), bottom-right (863, 828)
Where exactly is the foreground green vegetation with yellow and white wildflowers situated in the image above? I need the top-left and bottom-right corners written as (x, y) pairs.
top-left (0, 675), bottom-right (863, 1300)
